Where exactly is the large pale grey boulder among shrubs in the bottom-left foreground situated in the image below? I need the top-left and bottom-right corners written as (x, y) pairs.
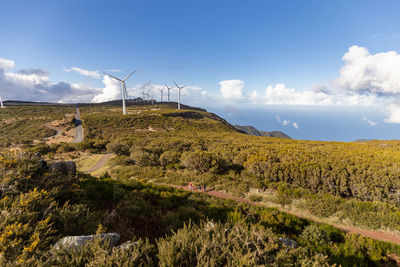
top-left (54, 233), bottom-right (120, 250)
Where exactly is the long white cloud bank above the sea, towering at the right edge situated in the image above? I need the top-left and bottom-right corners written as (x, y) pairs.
top-left (220, 46), bottom-right (400, 123)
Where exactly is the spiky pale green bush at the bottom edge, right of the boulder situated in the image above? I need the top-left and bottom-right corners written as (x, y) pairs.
top-left (157, 221), bottom-right (329, 266)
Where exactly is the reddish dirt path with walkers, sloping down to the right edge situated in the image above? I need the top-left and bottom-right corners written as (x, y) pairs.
top-left (161, 184), bottom-right (400, 245)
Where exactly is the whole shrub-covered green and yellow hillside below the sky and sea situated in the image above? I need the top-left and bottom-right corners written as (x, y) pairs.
top-left (0, 102), bottom-right (400, 266)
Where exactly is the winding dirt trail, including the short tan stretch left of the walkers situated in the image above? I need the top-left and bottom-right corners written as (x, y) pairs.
top-left (87, 153), bottom-right (400, 248)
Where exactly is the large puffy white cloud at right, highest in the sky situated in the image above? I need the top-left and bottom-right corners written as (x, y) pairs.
top-left (336, 45), bottom-right (400, 94)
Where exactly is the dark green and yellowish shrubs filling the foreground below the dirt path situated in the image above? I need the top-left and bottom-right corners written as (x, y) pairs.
top-left (0, 154), bottom-right (399, 266)
